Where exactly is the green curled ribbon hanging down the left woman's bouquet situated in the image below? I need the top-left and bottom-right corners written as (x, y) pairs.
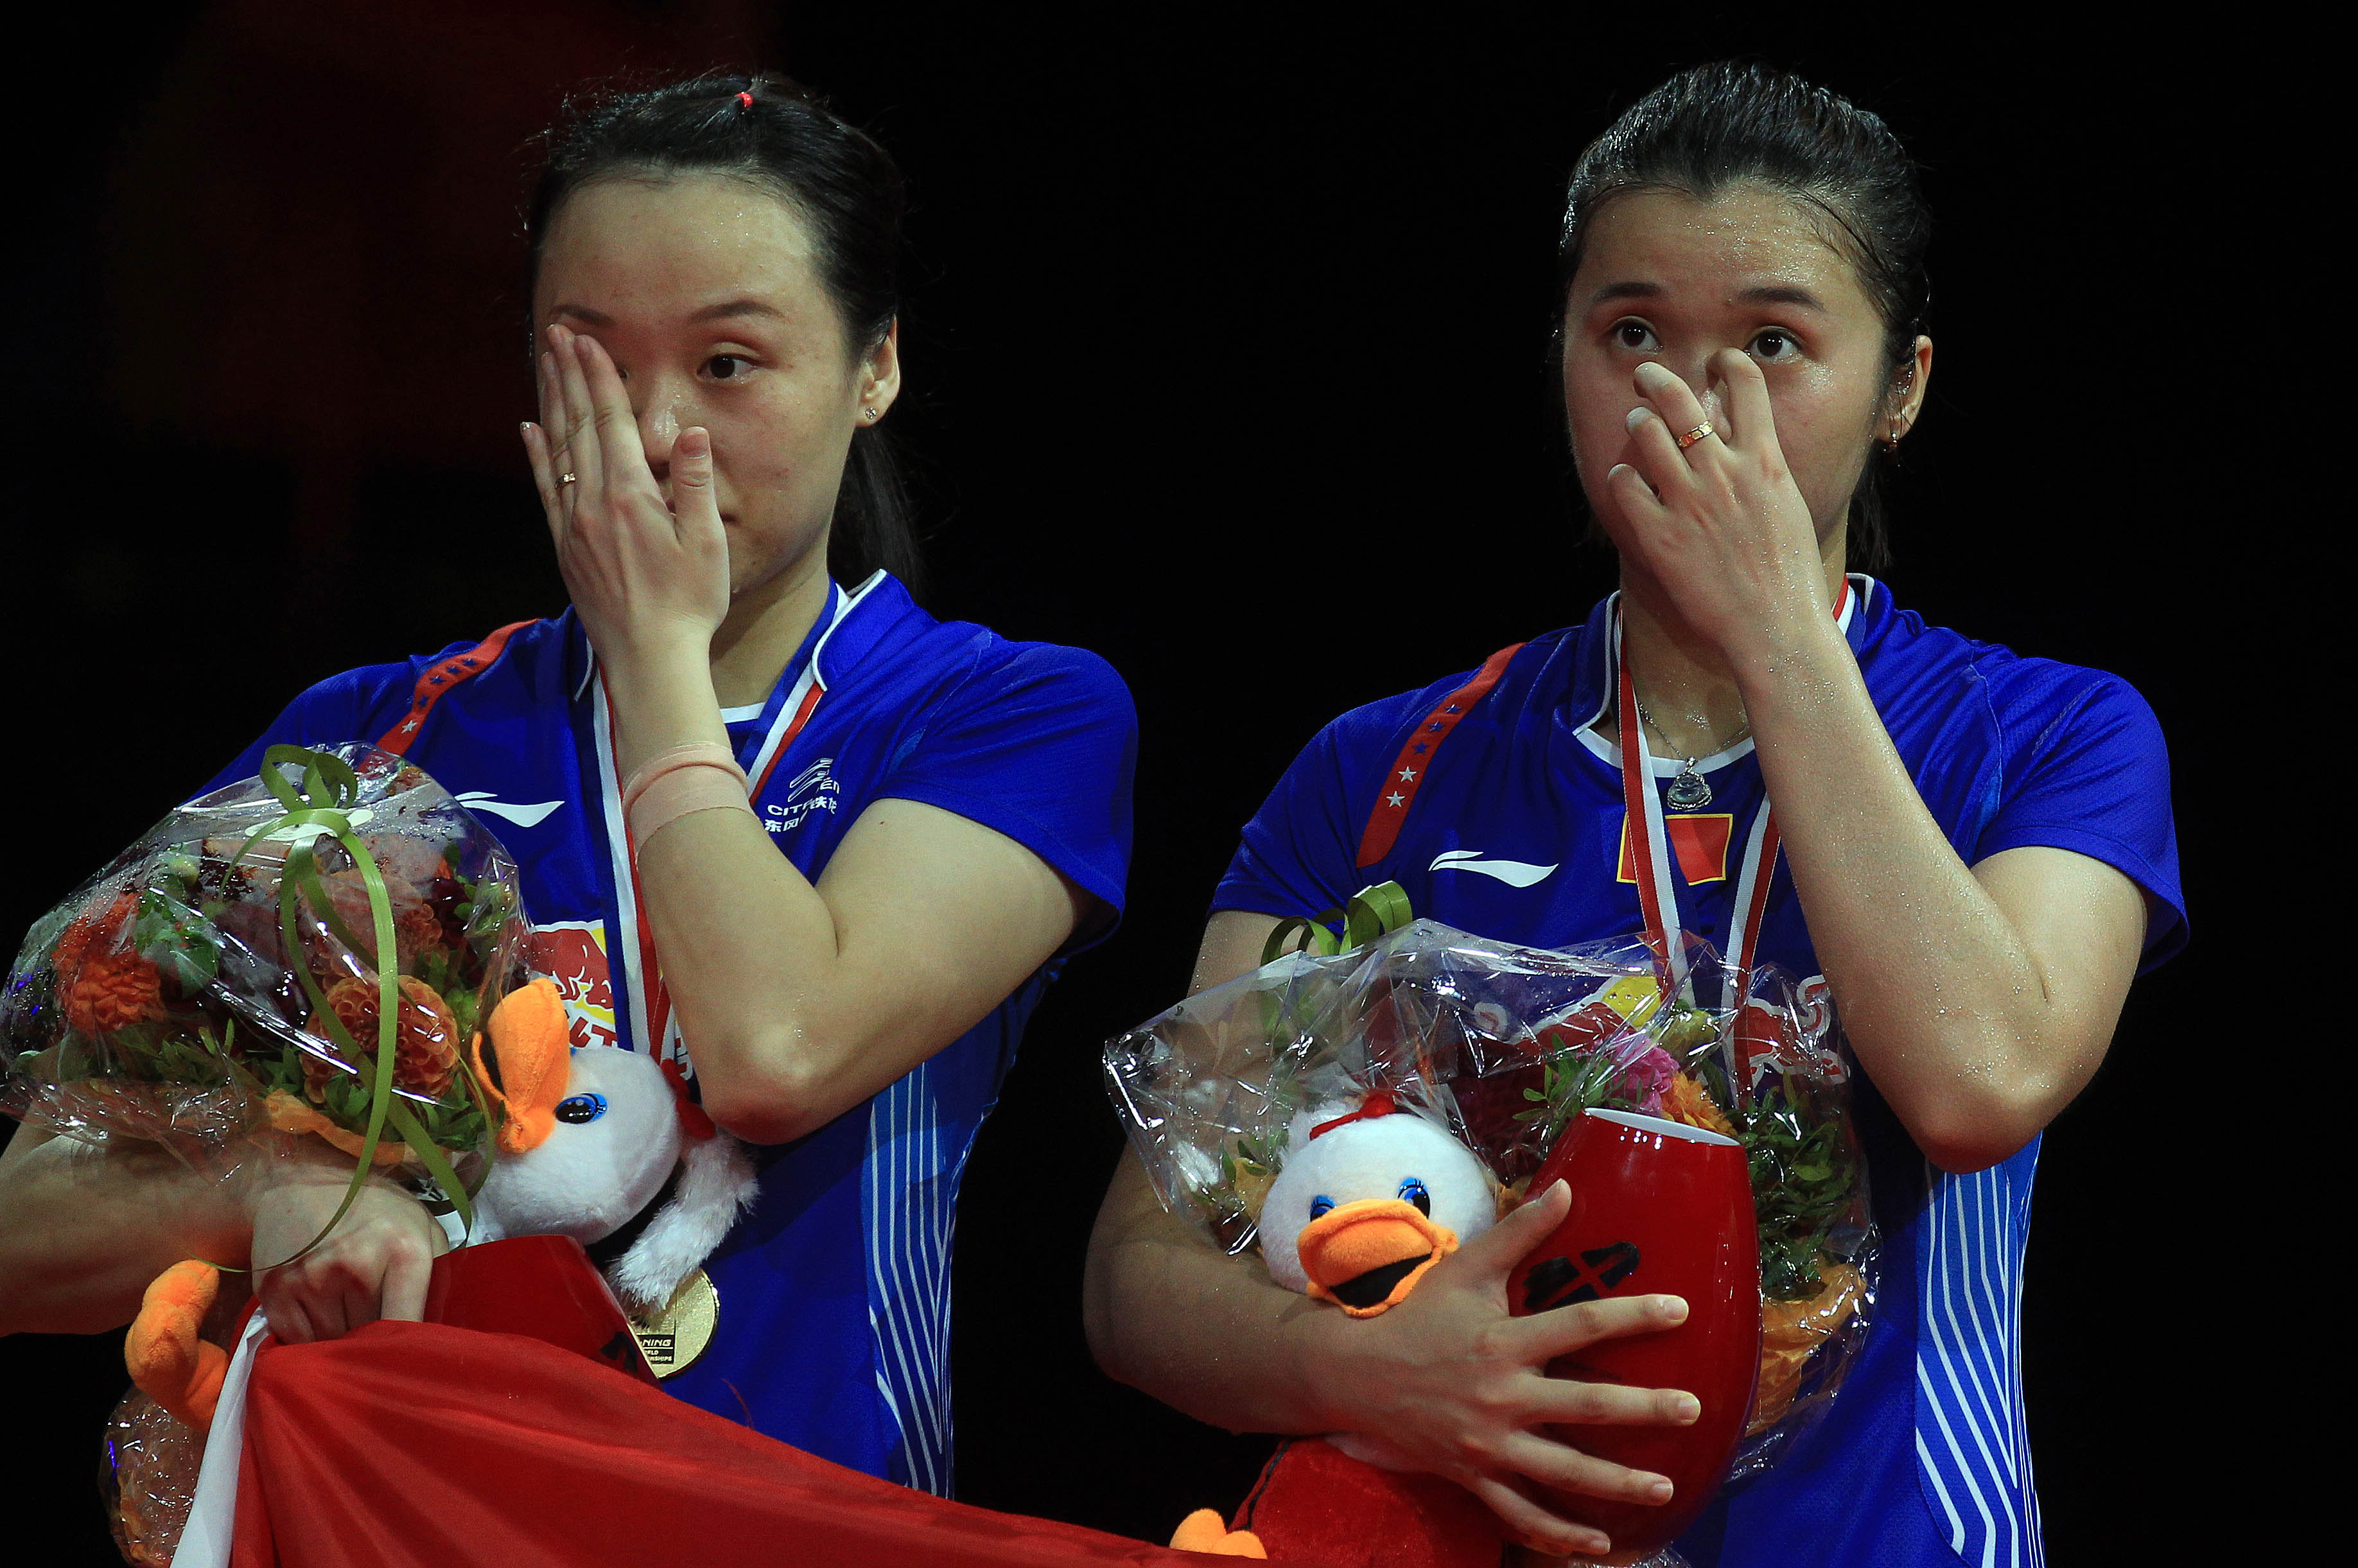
top-left (229, 745), bottom-right (498, 1269)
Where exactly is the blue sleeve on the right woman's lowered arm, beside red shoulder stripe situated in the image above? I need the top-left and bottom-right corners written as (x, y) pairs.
top-left (1212, 691), bottom-right (1429, 915)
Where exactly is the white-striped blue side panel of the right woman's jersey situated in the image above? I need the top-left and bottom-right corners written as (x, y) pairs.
top-left (1915, 1139), bottom-right (2047, 1568)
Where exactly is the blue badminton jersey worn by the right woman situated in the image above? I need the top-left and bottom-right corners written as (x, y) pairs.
top-left (1214, 575), bottom-right (2186, 1568)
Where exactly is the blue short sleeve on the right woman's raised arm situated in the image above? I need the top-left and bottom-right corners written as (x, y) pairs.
top-left (1971, 672), bottom-right (2186, 971)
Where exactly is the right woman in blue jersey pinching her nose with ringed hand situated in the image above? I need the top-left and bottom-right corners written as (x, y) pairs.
top-left (1087, 66), bottom-right (2183, 1568)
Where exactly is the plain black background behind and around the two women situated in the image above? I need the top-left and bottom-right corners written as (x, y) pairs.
top-left (0, 0), bottom-right (2304, 1564)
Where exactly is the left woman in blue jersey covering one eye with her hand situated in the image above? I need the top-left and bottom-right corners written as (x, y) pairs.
top-left (0, 78), bottom-right (1137, 1492)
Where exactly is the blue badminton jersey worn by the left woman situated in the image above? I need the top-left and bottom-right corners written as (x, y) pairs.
top-left (219, 573), bottom-right (1137, 1495)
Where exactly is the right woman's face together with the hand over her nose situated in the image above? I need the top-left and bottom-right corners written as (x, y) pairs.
top-left (1564, 184), bottom-right (1931, 646)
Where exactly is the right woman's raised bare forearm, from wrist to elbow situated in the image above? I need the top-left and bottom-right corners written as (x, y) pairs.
top-left (1731, 618), bottom-right (2124, 1169)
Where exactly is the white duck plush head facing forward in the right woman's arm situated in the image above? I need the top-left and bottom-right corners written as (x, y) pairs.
top-left (1259, 1092), bottom-right (1498, 1318)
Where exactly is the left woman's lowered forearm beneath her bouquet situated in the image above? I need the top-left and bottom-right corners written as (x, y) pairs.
top-left (0, 1127), bottom-right (252, 1334)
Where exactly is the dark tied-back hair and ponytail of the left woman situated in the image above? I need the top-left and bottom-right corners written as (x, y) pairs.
top-left (526, 73), bottom-right (924, 592)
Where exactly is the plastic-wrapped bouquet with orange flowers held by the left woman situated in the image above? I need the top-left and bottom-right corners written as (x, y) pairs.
top-left (0, 743), bottom-right (526, 1210)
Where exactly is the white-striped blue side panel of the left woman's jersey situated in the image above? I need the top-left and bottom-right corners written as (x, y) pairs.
top-left (860, 1063), bottom-right (965, 1497)
